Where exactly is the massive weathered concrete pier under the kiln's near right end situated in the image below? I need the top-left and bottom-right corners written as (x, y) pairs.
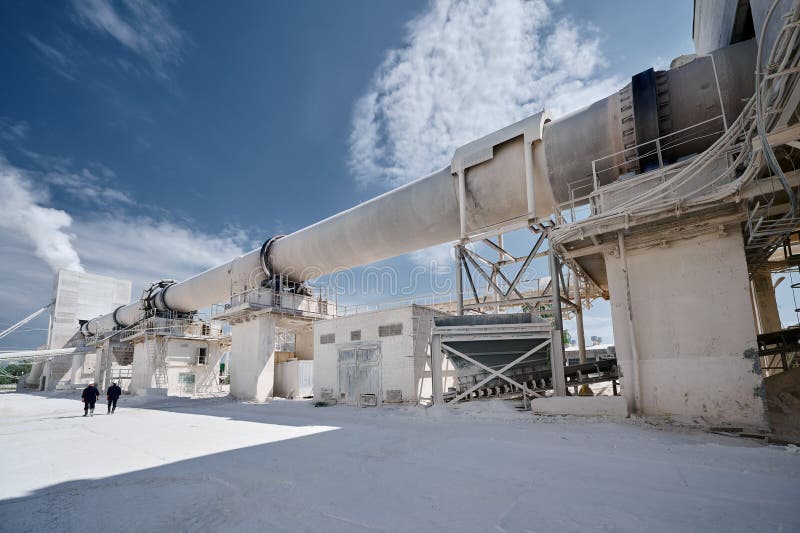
top-left (605, 230), bottom-right (767, 428)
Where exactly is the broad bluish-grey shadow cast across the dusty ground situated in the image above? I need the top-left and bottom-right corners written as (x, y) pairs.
top-left (0, 390), bottom-right (800, 532)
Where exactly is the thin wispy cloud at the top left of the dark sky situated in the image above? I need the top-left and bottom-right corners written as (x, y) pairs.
top-left (73, 0), bottom-right (187, 77)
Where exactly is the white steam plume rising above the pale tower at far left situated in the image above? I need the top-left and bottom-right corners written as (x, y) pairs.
top-left (0, 156), bottom-right (83, 271)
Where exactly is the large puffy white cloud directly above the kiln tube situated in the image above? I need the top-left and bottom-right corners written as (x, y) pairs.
top-left (350, 0), bottom-right (624, 187)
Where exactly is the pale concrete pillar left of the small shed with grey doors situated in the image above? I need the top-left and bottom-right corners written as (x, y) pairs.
top-left (230, 315), bottom-right (277, 402)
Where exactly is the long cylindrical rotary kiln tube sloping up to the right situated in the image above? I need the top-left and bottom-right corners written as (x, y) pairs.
top-left (83, 40), bottom-right (756, 334)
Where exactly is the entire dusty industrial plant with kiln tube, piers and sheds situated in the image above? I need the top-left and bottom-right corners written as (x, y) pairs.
top-left (3, 0), bottom-right (800, 440)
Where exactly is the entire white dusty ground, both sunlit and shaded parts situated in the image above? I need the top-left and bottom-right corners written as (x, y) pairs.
top-left (0, 393), bottom-right (800, 533)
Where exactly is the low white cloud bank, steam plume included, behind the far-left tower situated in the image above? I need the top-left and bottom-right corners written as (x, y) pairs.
top-left (0, 154), bottom-right (256, 349)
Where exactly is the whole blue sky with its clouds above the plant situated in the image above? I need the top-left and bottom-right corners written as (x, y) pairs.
top-left (0, 0), bottom-right (712, 349)
